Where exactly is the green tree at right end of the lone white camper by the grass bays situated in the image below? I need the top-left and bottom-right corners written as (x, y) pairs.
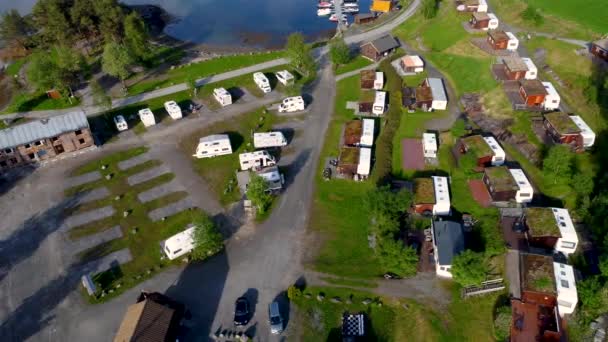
top-left (192, 214), bottom-right (224, 260)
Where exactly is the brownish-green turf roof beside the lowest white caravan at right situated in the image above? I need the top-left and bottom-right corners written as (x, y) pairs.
top-left (520, 253), bottom-right (557, 295)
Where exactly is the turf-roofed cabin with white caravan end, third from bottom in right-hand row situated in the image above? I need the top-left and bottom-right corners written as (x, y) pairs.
top-left (483, 166), bottom-right (534, 203)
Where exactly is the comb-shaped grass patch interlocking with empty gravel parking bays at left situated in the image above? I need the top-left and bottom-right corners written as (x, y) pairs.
top-left (65, 147), bottom-right (201, 302)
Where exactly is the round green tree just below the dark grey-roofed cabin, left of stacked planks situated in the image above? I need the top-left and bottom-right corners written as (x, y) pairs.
top-left (451, 250), bottom-right (489, 286)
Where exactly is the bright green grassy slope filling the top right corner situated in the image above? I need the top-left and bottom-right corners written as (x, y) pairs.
top-left (491, 0), bottom-right (608, 40)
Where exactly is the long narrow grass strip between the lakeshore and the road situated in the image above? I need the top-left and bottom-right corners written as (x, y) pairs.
top-left (128, 51), bottom-right (283, 95)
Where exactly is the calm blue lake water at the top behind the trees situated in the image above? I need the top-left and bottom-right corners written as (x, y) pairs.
top-left (0, 0), bottom-right (371, 47)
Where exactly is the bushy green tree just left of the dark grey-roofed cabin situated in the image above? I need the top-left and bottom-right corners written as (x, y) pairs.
top-left (376, 239), bottom-right (418, 277)
